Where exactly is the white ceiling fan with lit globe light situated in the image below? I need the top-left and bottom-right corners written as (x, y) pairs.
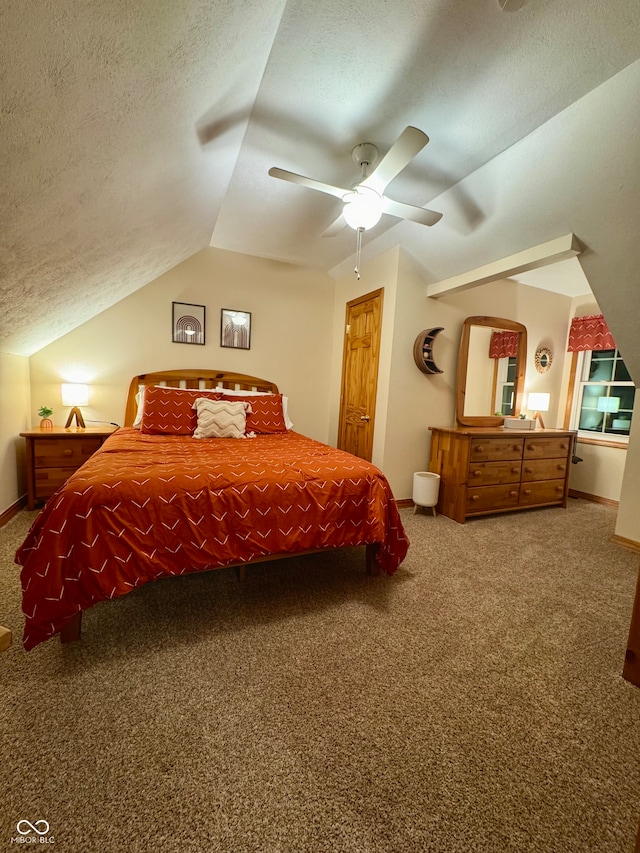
top-left (269, 126), bottom-right (442, 237)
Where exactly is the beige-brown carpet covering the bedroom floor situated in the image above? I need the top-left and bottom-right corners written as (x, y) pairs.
top-left (0, 500), bottom-right (640, 853)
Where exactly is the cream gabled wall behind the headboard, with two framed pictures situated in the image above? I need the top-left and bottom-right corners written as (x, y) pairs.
top-left (31, 248), bottom-right (334, 441)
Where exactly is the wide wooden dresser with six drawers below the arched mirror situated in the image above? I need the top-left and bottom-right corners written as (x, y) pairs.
top-left (429, 427), bottom-right (576, 524)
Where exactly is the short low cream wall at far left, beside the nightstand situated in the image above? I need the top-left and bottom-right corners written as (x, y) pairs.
top-left (0, 353), bottom-right (31, 514)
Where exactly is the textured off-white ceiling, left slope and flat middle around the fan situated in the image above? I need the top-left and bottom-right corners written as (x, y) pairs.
top-left (0, 0), bottom-right (640, 355)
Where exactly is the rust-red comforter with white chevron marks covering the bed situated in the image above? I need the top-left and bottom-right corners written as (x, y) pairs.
top-left (16, 428), bottom-right (409, 649)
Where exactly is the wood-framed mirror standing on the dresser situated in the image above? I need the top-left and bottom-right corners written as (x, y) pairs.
top-left (456, 317), bottom-right (527, 427)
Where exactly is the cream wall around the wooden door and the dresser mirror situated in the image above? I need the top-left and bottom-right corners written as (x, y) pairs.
top-left (330, 249), bottom-right (572, 499)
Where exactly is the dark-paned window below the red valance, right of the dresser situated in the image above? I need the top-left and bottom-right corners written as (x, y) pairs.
top-left (571, 349), bottom-right (636, 442)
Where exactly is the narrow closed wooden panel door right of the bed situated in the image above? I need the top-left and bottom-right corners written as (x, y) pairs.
top-left (338, 288), bottom-right (384, 462)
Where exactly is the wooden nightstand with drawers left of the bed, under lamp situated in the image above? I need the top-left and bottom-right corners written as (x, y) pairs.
top-left (20, 426), bottom-right (117, 509)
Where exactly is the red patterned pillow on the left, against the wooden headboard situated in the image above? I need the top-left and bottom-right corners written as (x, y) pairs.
top-left (140, 385), bottom-right (222, 435)
